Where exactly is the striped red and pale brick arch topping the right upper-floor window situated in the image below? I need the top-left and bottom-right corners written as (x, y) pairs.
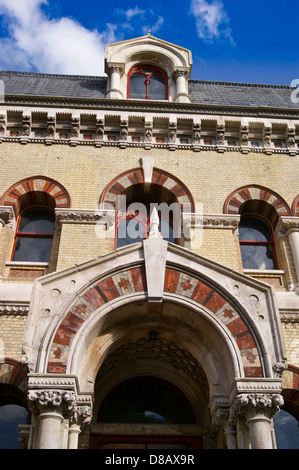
top-left (224, 185), bottom-right (291, 225)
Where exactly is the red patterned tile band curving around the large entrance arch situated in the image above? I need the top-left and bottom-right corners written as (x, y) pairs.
top-left (47, 266), bottom-right (263, 377)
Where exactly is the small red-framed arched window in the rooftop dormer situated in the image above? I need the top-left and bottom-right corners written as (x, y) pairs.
top-left (128, 65), bottom-right (168, 100)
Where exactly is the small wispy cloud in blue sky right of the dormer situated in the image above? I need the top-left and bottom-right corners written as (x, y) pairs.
top-left (190, 0), bottom-right (234, 45)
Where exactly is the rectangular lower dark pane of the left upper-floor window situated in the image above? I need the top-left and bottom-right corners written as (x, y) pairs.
top-left (13, 237), bottom-right (52, 263)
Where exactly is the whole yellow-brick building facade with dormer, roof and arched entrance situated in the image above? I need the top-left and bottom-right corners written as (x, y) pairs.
top-left (0, 34), bottom-right (299, 449)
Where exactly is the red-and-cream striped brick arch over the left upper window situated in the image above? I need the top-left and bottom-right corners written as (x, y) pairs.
top-left (0, 176), bottom-right (70, 217)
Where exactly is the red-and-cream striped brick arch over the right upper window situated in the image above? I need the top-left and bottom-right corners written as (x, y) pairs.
top-left (223, 184), bottom-right (291, 224)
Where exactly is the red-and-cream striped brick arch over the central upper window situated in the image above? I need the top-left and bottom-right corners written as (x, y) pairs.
top-left (100, 168), bottom-right (195, 212)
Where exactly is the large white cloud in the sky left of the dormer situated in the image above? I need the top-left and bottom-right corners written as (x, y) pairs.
top-left (0, 0), bottom-right (115, 75)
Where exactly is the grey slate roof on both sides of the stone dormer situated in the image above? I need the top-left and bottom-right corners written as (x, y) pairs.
top-left (0, 72), bottom-right (299, 110)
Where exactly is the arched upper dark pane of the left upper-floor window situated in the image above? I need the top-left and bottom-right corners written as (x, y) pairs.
top-left (18, 210), bottom-right (54, 234)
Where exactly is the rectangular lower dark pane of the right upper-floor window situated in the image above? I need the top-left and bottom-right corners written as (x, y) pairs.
top-left (241, 244), bottom-right (276, 269)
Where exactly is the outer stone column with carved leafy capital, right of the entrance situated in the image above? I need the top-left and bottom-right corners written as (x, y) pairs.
top-left (235, 393), bottom-right (283, 449)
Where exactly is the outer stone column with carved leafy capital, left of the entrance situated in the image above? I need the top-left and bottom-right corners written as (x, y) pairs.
top-left (28, 389), bottom-right (75, 449)
